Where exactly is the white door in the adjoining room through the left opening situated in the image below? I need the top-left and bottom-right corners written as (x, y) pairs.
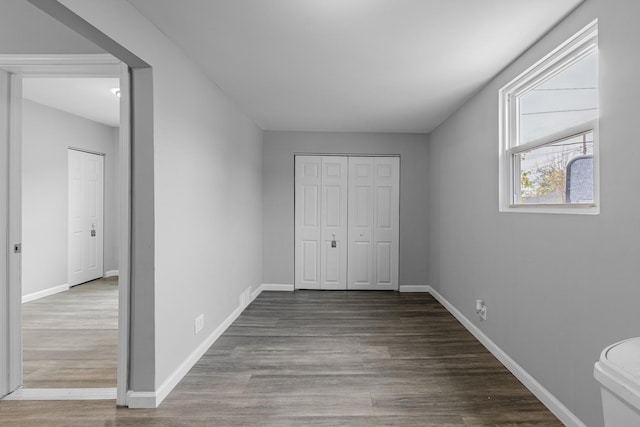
top-left (69, 149), bottom-right (104, 286)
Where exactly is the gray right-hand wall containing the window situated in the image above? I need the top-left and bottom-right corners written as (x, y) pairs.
top-left (425, 0), bottom-right (640, 426)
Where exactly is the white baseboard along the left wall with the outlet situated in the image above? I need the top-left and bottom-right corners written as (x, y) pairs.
top-left (127, 286), bottom-right (262, 408)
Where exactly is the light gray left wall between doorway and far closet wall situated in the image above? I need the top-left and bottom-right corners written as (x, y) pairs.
top-left (61, 0), bottom-right (262, 398)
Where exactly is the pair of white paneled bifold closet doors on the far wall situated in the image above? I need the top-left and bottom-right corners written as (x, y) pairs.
top-left (295, 155), bottom-right (400, 290)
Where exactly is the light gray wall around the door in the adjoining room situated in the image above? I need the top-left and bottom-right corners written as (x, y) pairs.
top-left (22, 99), bottom-right (119, 296)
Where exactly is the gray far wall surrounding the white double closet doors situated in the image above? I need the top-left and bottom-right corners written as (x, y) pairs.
top-left (262, 131), bottom-right (428, 285)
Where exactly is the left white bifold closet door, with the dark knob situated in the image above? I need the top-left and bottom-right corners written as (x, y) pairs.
top-left (295, 156), bottom-right (348, 289)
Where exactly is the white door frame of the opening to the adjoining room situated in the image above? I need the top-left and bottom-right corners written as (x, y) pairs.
top-left (0, 54), bottom-right (131, 406)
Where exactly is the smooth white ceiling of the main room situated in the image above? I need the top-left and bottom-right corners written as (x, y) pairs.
top-left (129, 0), bottom-right (582, 132)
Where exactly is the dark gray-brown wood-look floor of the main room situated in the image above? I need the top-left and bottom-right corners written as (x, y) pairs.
top-left (0, 291), bottom-right (562, 427)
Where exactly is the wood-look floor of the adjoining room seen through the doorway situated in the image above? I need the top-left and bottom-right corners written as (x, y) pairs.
top-left (22, 277), bottom-right (118, 388)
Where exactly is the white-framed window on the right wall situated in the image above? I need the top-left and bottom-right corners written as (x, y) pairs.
top-left (500, 21), bottom-right (599, 214)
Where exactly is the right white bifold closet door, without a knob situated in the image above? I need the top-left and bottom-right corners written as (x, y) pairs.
top-left (347, 157), bottom-right (400, 290)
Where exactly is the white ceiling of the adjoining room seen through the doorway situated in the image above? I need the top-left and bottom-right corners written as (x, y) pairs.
top-left (22, 77), bottom-right (120, 127)
